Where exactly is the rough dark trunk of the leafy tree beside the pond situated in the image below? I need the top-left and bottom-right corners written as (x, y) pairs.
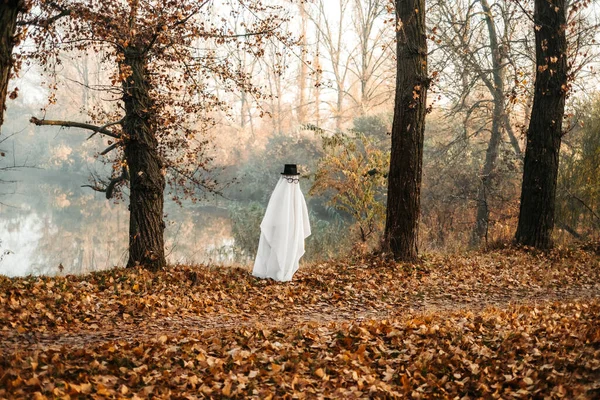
top-left (122, 48), bottom-right (166, 270)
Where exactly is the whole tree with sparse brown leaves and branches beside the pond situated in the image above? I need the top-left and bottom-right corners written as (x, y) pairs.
top-left (31, 0), bottom-right (288, 270)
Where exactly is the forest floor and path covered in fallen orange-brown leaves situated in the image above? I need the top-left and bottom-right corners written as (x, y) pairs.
top-left (0, 245), bottom-right (600, 399)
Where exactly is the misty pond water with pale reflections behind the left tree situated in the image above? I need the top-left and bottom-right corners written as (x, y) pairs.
top-left (0, 185), bottom-right (239, 276)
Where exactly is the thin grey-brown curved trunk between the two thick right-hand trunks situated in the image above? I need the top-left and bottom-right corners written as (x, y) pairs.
top-left (471, 0), bottom-right (505, 245)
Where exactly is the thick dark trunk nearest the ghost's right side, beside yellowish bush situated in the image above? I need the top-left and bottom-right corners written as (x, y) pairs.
top-left (383, 0), bottom-right (429, 261)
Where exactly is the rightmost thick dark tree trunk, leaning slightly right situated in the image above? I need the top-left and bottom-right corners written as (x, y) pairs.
top-left (515, 0), bottom-right (567, 249)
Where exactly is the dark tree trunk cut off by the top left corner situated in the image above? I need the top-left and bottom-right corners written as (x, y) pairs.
top-left (0, 0), bottom-right (24, 127)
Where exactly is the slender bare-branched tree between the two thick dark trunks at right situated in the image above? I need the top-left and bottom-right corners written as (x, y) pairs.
top-left (428, 0), bottom-right (531, 245)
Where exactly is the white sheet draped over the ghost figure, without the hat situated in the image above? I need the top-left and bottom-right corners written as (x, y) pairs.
top-left (252, 176), bottom-right (310, 282)
